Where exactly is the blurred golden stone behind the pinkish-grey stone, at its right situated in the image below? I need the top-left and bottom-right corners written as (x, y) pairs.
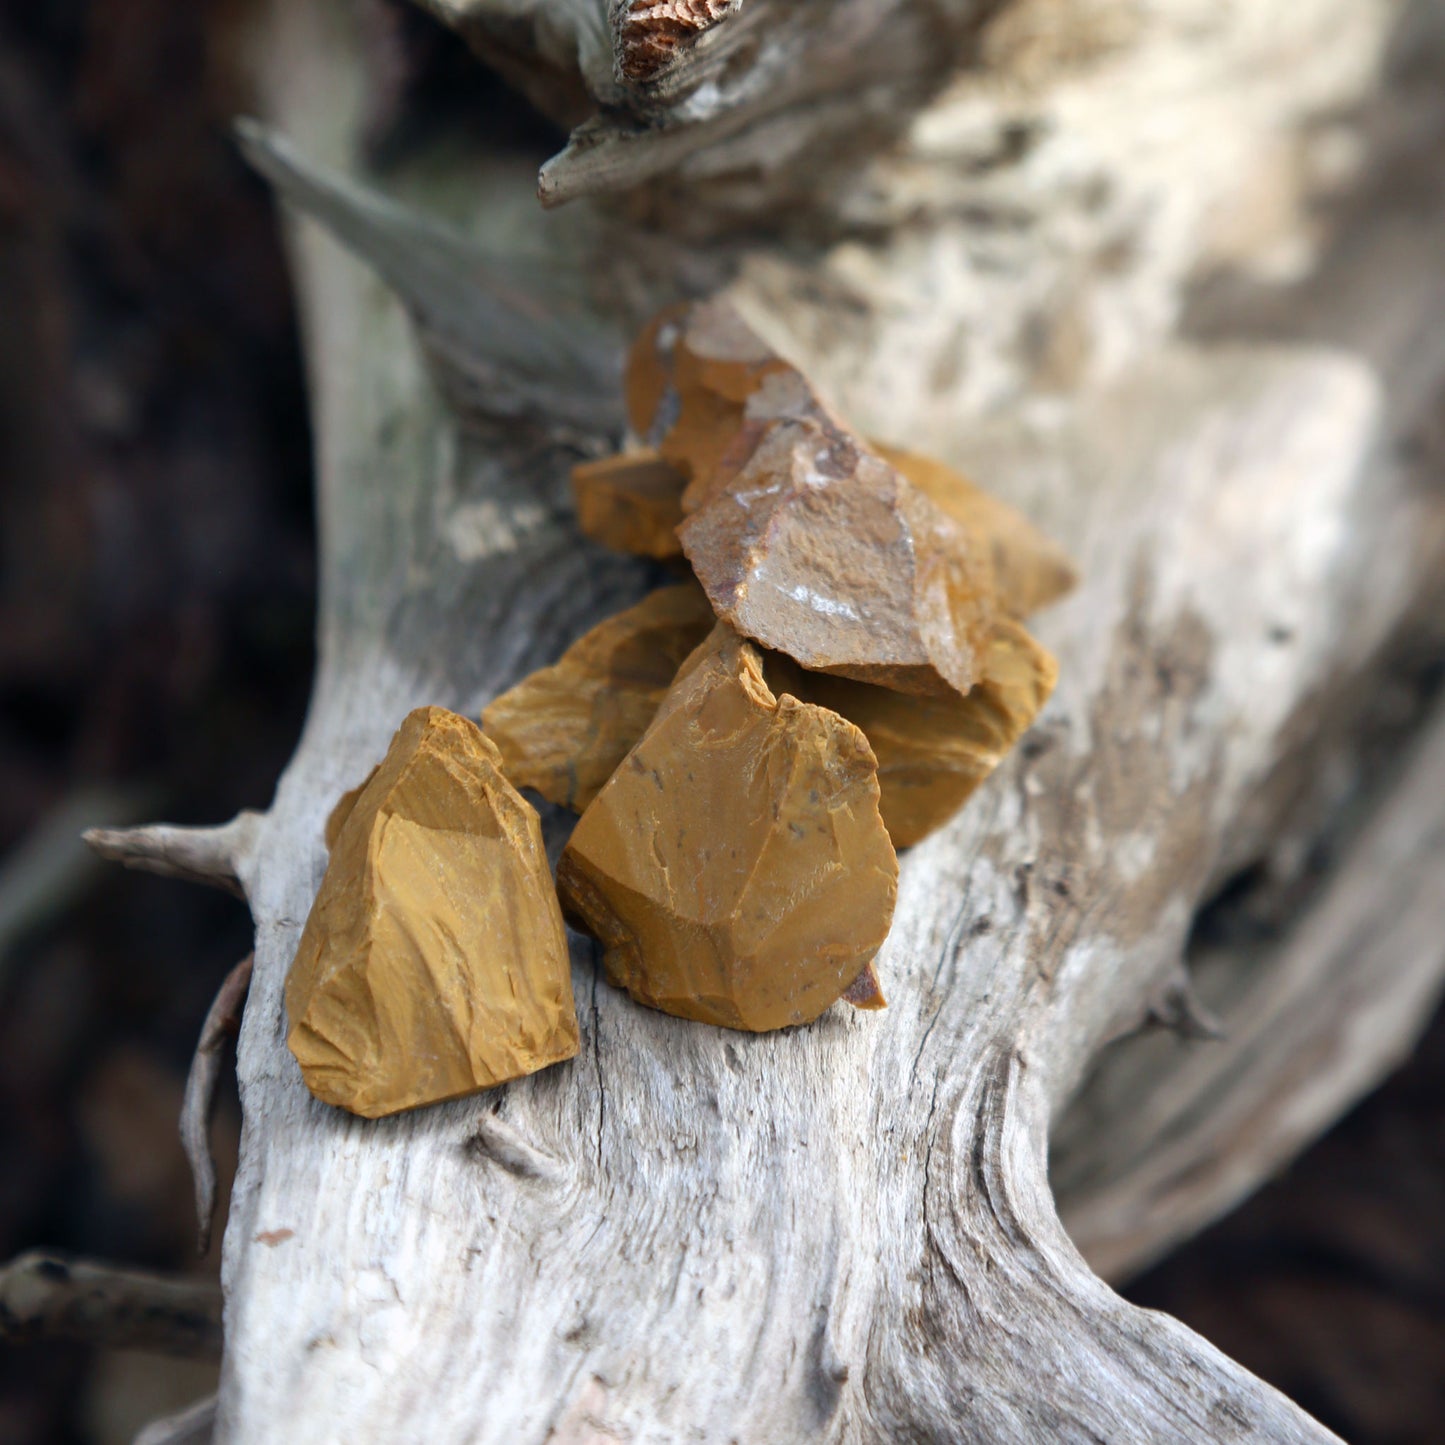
top-left (871, 442), bottom-right (1078, 617)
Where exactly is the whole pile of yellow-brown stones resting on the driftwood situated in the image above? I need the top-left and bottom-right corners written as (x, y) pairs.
top-left (286, 301), bottom-right (1072, 1114)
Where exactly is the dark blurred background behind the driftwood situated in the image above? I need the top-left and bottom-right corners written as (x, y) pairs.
top-left (0, 0), bottom-right (1445, 1445)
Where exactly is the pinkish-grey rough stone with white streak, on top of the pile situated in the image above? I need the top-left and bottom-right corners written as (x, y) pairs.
top-left (678, 379), bottom-right (996, 695)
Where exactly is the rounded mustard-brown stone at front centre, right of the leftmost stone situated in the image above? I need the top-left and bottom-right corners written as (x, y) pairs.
top-left (558, 626), bottom-right (897, 1032)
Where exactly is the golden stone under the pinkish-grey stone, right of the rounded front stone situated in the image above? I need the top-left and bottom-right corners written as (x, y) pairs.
top-left (798, 618), bottom-right (1058, 848)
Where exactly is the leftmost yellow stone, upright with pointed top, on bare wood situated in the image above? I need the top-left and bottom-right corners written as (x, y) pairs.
top-left (286, 708), bottom-right (578, 1118)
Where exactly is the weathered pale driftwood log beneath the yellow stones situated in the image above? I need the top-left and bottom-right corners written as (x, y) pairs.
top-left (79, 0), bottom-right (1445, 1445)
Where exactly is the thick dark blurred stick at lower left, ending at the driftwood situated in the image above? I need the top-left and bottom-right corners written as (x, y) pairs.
top-left (0, 1250), bottom-right (221, 1360)
